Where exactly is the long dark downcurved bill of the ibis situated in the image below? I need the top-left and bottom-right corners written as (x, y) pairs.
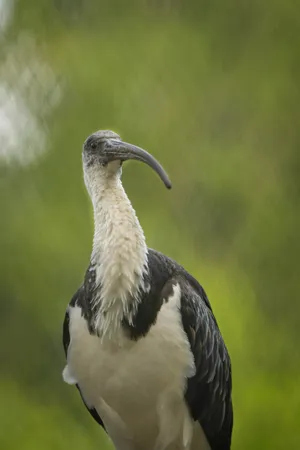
top-left (106, 139), bottom-right (172, 189)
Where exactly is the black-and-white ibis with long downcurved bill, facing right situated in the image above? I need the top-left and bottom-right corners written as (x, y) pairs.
top-left (62, 130), bottom-right (233, 450)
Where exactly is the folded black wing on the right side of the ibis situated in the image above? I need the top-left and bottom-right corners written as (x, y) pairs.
top-left (180, 273), bottom-right (233, 450)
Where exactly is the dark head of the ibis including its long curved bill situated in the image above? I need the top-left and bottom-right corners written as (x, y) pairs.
top-left (82, 130), bottom-right (171, 195)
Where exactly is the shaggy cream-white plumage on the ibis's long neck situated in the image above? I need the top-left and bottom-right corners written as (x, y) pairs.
top-left (91, 176), bottom-right (148, 337)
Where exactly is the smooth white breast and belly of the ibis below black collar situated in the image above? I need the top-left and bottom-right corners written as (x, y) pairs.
top-left (64, 285), bottom-right (209, 450)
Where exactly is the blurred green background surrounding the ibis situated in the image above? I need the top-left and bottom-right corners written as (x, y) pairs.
top-left (0, 0), bottom-right (300, 450)
